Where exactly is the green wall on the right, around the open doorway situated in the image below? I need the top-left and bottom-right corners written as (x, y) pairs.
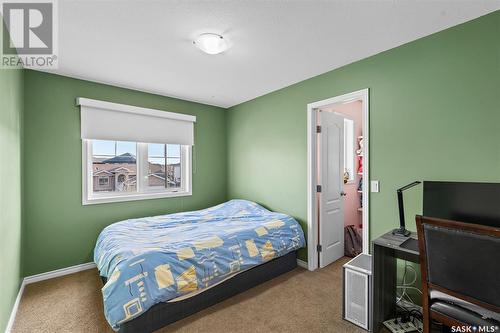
top-left (227, 11), bottom-right (500, 259)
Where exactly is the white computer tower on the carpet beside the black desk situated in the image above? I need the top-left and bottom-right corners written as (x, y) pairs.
top-left (343, 254), bottom-right (372, 331)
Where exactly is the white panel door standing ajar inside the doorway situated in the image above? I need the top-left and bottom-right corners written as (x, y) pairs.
top-left (318, 111), bottom-right (345, 268)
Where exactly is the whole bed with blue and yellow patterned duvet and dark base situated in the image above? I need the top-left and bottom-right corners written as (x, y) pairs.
top-left (94, 200), bottom-right (305, 332)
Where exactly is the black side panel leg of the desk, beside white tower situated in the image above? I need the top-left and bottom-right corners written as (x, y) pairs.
top-left (372, 244), bottom-right (397, 333)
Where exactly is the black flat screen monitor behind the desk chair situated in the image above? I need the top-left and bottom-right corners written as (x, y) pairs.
top-left (423, 181), bottom-right (500, 227)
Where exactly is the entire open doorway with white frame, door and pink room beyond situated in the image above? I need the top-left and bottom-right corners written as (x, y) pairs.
top-left (307, 89), bottom-right (369, 270)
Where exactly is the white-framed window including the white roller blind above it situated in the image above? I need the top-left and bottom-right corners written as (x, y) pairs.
top-left (76, 98), bottom-right (196, 205)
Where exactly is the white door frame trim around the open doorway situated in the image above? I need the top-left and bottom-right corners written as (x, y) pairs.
top-left (307, 88), bottom-right (370, 271)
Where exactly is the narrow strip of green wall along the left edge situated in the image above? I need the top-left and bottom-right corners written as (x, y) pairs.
top-left (0, 63), bottom-right (23, 332)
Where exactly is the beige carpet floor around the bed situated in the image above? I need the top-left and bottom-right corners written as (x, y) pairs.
top-left (13, 258), bottom-right (364, 333)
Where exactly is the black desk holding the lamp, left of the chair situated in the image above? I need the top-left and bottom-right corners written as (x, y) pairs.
top-left (372, 232), bottom-right (419, 333)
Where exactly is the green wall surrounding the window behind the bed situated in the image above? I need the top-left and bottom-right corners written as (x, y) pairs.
top-left (23, 70), bottom-right (227, 276)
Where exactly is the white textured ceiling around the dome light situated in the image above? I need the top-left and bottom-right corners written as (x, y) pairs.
top-left (44, 0), bottom-right (500, 107)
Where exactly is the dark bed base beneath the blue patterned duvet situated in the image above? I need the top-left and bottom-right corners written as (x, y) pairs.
top-left (103, 251), bottom-right (297, 333)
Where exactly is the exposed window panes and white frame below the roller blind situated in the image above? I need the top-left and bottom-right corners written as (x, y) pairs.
top-left (83, 140), bottom-right (191, 204)
